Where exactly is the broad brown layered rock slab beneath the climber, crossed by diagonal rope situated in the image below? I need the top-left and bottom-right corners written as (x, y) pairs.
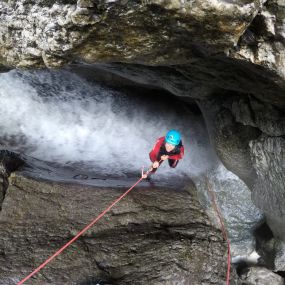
top-left (0, 169), bottom-right (234, 285)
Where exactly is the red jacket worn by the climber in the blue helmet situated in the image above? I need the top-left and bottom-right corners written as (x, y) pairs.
top-left (149, 137), bottom-right (184, 162)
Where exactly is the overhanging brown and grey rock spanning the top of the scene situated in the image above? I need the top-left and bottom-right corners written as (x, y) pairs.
top-left (0, 0), bottom-right (285, 101)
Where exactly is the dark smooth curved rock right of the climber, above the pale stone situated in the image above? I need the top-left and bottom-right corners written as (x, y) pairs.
top-left (199, 97), bottom-right (261, 189)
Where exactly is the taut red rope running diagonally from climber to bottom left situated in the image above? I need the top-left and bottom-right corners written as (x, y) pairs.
top-left (17, 175), bottom-right (142, 285)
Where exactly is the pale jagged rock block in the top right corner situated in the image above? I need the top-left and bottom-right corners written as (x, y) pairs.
top-left (231, 0), bottom-right (285, 78)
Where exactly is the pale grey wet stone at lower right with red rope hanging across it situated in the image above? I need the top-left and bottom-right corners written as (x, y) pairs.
top-left (194, 164), bottom-right (263, 260)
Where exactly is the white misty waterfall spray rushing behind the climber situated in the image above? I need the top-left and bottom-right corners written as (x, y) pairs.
top-left (0, 71), bottom-right (213, 176)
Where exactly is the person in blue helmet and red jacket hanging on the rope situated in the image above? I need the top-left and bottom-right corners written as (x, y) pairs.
top-left (142, 130), bottom-right (184, 178)
